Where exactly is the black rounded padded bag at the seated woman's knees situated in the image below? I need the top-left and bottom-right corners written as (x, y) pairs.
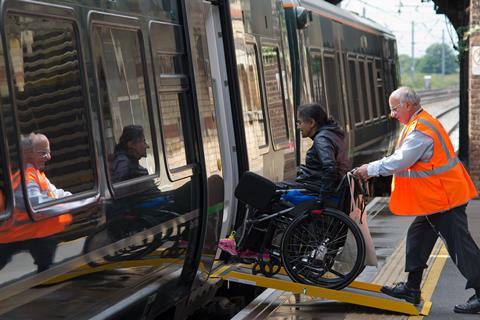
top-left (235, 171), bottom-right (277, 210)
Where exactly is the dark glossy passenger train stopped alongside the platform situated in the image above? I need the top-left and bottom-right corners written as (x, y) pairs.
top-left (0, 0), bottom-right (399, 319)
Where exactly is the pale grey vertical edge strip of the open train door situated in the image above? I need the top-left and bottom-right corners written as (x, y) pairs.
top-left (205, 4), bottom-right (238, 242)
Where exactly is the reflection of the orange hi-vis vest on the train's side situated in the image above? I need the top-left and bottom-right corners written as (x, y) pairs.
top-left (0, 168), bottom-right (72, 243)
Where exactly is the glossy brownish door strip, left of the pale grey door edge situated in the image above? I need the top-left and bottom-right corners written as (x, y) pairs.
top-left (178, 0), bottom-right (225, 303)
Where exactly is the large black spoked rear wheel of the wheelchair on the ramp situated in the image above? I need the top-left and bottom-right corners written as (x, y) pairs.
top-left (281, 208), bottom-right (365, 289)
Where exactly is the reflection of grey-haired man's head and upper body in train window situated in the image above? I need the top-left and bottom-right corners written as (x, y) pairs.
top-left (21, 133), bottom-right (72, 206)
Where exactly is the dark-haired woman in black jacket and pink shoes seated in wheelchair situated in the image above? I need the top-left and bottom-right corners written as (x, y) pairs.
top-left (219, 103), bottom-right (350, 257)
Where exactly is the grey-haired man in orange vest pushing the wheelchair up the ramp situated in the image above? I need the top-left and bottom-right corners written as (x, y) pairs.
top-left (355, 87), bottom-right (480, 313)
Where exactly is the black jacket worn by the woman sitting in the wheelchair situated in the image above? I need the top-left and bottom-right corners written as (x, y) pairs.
top-left (295, 121), bottom-right (350, 198)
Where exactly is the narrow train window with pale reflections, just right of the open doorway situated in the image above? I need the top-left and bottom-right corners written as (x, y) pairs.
top-left (237, 44), bottom-right (267, 171)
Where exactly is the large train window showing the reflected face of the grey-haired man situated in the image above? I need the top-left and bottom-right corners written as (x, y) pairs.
top-left (6, 13), bottom-right (95, 208)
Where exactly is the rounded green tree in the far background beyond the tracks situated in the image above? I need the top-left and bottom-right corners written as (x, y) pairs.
top-left (417, 43), bottom-right (458, 74)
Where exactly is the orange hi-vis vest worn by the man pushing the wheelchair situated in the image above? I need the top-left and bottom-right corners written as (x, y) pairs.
top-left (390, 110), bottom-right (477, 216)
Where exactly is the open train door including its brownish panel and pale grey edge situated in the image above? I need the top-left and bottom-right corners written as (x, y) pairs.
top-left (177, 0), bottom-right (238, 312)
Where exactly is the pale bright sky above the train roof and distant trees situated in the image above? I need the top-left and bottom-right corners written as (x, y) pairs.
top-left (340, 0), bottom-right (457, 58)
